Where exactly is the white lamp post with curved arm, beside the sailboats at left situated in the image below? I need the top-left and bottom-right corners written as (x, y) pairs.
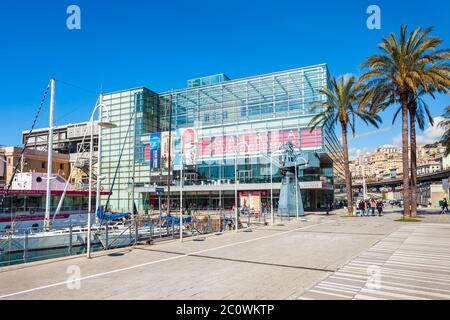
top-left (86, 95), bottom-right (117, 259)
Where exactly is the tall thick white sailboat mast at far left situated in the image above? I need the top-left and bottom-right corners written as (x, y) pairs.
top-left (44, 79), bottom-right (55, 231)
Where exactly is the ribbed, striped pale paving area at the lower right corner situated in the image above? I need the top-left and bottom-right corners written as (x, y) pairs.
top-left (301, 223), bottom-right (450, 300)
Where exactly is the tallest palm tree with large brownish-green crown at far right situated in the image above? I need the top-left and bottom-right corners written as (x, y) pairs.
top-left (361, 26), bottom-right (450, 215)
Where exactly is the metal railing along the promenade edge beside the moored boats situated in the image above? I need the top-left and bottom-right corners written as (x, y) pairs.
top-left (0, 208), bottom-right (306, 267)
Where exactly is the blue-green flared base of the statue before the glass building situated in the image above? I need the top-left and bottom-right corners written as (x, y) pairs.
top-left (278, 172), bottom-right (305, 217)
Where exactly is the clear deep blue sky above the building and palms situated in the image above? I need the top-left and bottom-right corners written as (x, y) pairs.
top-left (0, 0), bottom-right (450, 153)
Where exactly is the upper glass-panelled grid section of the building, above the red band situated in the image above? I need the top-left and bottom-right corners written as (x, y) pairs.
top-left (160, 64), bottom-right (329, 127)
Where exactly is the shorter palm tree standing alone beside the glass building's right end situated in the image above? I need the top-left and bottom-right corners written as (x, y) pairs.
top-left (309, 76), bottom-right (381, 215)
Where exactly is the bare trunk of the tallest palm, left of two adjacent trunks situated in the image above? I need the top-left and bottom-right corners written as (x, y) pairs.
top-left (400, 92), bottom-right (411, 217)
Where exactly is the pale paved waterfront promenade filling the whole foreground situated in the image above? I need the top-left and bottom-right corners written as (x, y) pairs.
top-left (0, 212), bottom-right (450, 300)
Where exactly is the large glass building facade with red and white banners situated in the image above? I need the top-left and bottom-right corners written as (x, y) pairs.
top-left (101, 65), bottom-right (342, 211)
